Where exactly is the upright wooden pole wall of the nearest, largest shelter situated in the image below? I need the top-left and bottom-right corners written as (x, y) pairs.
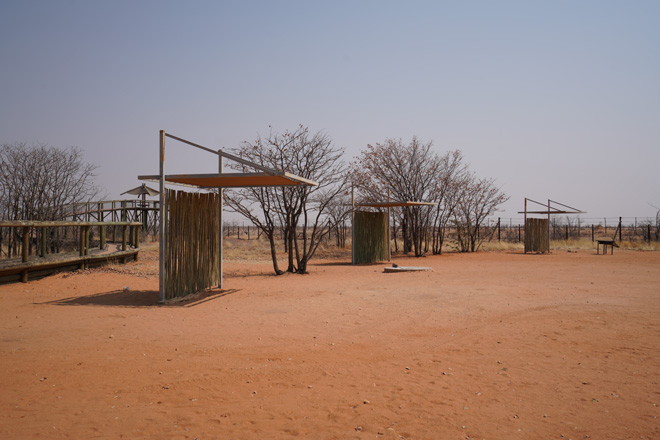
top-left (165, 190), bottom-right (220, 299)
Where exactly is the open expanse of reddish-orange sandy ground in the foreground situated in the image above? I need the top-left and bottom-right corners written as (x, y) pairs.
top-left (0, 250), bottom-right (660, 439)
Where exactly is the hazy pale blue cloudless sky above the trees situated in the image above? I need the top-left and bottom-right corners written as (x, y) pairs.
top-left (0, 0), bottom-right (660, 218)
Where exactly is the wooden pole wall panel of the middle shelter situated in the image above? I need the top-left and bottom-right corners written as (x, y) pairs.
top-left (353, 211), bottom-right (390, 264)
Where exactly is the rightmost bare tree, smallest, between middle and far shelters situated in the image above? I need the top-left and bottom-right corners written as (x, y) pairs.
top-left (454, 174), bottom-right (509, 252)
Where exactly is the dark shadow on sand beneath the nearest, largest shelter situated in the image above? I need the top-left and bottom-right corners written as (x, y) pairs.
top-left (38, 289), bottom-right (239, 307)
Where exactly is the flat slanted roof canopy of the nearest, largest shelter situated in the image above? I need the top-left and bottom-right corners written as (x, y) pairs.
top-left (138, 172), bottom-right (318, 188)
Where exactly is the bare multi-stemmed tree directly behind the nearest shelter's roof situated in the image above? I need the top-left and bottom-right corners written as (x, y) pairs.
top-left (225, 126), bottom-right (348, 274)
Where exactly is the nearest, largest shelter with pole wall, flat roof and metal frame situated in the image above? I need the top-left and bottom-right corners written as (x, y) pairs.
top-left (138, 130), bottom-right (318, 302)
